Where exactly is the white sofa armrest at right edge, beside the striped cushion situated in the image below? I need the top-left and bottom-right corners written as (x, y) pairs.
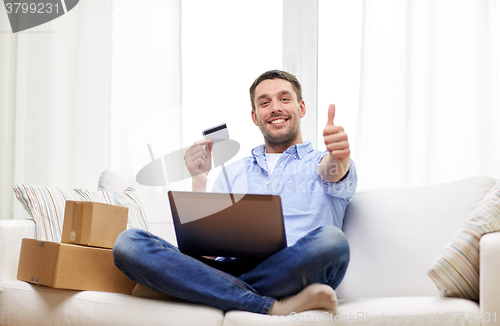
top-left (479, 232), bottom-right (500, 325)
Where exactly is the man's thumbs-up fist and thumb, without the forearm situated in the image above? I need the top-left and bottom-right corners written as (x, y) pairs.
top-left (323, 104), bottom-right (351, 163)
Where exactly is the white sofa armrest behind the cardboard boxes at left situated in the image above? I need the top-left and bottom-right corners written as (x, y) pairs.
top-left (0, 220), bottom-right (35, 285)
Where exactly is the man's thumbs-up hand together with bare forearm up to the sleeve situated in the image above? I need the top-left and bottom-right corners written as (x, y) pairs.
top-left (319, 104), bottom-right (351, 182)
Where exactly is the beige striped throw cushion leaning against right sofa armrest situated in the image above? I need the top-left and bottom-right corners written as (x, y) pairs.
top-left (428, 187), bottom-right (500, 301)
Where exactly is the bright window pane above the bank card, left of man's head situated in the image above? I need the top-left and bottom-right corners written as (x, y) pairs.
top-left (182, 0), bottom-right (283, 187)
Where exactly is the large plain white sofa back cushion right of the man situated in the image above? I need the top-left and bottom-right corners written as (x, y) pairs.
top-left (337, 177), bottom-right (496, 299)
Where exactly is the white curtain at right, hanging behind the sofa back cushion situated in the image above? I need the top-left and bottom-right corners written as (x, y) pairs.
top-left (354, 0), bottom-right (500, 188)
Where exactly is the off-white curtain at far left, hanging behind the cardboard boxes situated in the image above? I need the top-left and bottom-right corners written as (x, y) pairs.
top-left (0, 0), bottom-right (112, 218)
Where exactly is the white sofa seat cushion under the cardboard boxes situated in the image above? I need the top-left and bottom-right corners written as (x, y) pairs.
top-left (0, 281), bottom-right (224, 326)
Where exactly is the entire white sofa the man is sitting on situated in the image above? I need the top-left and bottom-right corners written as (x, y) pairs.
top-left (0, 171), bottom-right (500, 326)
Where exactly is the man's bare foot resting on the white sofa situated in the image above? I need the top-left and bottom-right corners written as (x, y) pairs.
top-left (269, 283), bottom-right (338, 316)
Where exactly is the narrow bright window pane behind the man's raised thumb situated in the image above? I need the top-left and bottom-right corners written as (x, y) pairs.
top-left (318, 0), bottom-right (363, 157)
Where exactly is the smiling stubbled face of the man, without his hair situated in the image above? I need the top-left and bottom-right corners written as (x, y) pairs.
top-left (252, 78), bottom-right (306, 145)
